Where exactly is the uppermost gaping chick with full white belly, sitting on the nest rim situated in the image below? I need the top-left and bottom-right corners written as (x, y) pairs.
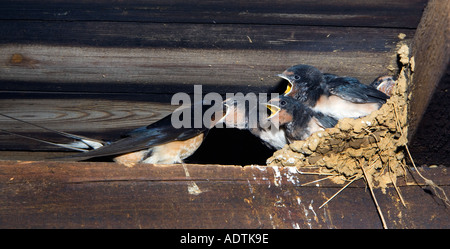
top-left (277, 64), bottom-right (389, 119)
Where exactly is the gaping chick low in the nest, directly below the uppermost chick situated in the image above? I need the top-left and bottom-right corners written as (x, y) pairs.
top-left (267, 96), bottom-right (337, 143)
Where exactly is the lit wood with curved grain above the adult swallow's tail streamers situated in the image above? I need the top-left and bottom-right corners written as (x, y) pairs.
top-left (0, 95), bottom-right (178, 133)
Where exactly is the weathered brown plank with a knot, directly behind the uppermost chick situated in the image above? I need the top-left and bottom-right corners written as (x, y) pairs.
top-left (0, 42), bottom-right (406, 94)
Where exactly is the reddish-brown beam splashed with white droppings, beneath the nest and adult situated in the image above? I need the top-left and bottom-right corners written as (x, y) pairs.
top-left (0, 161), bottom-right (450, 228)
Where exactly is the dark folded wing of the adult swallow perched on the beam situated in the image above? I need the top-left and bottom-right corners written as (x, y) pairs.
top-left (64, 115), bottom-right (209, 160)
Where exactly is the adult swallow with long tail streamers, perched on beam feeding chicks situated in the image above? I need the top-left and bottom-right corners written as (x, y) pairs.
top-left (2, 103), bottom-right (227, 167)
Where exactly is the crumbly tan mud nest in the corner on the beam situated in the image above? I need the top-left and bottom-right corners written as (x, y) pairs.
top-left (267, 45), bottom-right (414, 190)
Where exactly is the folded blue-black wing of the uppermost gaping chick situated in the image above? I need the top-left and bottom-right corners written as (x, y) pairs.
top-left (327, 77), bottom-right (389, 104)
